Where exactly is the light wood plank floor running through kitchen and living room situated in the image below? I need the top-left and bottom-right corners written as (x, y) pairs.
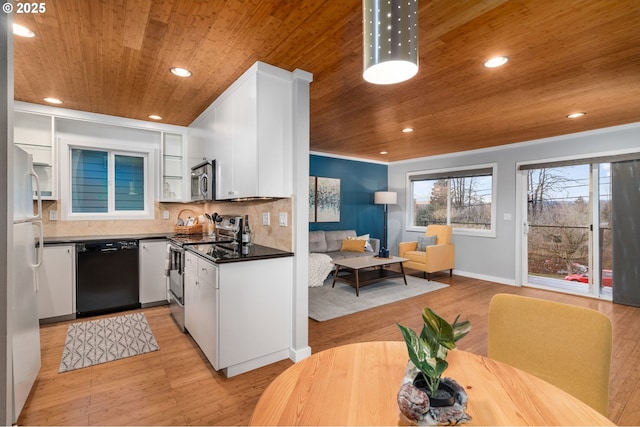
top-left (19, 274), bottom-right (640, 425)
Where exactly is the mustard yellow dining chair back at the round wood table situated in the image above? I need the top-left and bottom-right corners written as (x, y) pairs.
top-left (488, 294), bottom-right (612, 416)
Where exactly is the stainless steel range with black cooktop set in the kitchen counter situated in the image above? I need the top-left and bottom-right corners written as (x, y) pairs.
top-left (167, 215), bottom-right (242, 332)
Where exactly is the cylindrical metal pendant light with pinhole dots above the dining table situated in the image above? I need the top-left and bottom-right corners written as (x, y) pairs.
top-left (362, 0), bottom-right (418, 84)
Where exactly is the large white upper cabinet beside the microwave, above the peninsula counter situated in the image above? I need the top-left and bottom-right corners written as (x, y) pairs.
top-left (215, 62), bottom-right (293, 200)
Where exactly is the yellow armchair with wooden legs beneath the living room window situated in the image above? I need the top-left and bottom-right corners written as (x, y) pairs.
top-left (398, 225), bottom-right (456, 280)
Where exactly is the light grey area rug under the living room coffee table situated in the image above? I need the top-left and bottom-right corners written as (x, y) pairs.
top-left (309, 276), bottom-right (449, 322)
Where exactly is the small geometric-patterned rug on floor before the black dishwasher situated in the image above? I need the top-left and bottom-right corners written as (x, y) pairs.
top-left (58, 313), bottom-right (160, 373)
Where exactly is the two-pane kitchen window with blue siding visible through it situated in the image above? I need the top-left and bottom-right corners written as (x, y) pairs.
top-left (70, 148), bottom-right (145, 213)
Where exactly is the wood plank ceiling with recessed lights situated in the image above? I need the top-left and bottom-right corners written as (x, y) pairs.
top-left (13, 0), bottom-right (640, 161)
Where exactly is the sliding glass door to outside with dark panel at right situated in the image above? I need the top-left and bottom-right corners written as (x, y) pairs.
top-left (518, 153), bottom-right (640, 300)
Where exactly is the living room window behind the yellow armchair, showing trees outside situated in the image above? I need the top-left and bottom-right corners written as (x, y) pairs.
top-left (407, 165), bottom-right (495, 234)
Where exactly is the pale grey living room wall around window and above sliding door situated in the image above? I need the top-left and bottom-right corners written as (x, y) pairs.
top-left (388, 123), bottom-right (640, 284)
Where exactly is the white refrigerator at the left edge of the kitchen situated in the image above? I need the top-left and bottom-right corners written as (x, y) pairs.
top-left (9, 146), bottom-right (43, 424)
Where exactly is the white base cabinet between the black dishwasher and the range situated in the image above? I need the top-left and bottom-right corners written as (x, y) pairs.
top-left (138, 239), bottom-right (167, 307)
